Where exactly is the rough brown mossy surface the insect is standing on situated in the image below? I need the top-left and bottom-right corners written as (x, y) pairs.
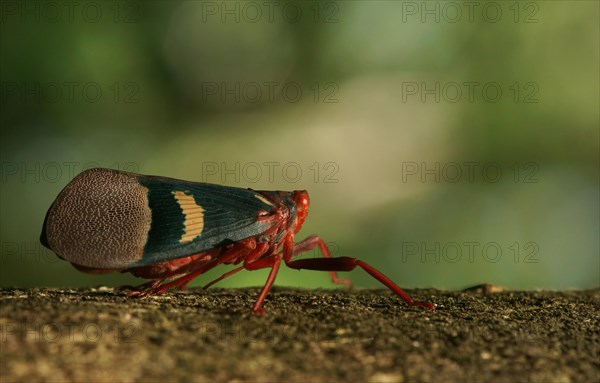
top-left (0, 288), bottom-right (600, 383)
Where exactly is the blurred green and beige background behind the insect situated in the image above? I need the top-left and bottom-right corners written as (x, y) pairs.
top-left (0, 1), bottom-right (600, 289)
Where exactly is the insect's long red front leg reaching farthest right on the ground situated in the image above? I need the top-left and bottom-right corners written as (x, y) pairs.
top-left (284, 237), bottom-right (435, 310)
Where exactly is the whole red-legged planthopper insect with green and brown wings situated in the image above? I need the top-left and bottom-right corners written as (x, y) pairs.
top-left (40, 168), bottom-right (435, 314)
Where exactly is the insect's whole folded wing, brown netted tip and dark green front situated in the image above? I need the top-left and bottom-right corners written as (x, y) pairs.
top-left (40, 168), bottom-right (280, 271)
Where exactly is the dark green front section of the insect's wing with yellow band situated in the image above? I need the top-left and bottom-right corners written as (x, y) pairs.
top-left (131, 176), bottom-right (277, 266)
